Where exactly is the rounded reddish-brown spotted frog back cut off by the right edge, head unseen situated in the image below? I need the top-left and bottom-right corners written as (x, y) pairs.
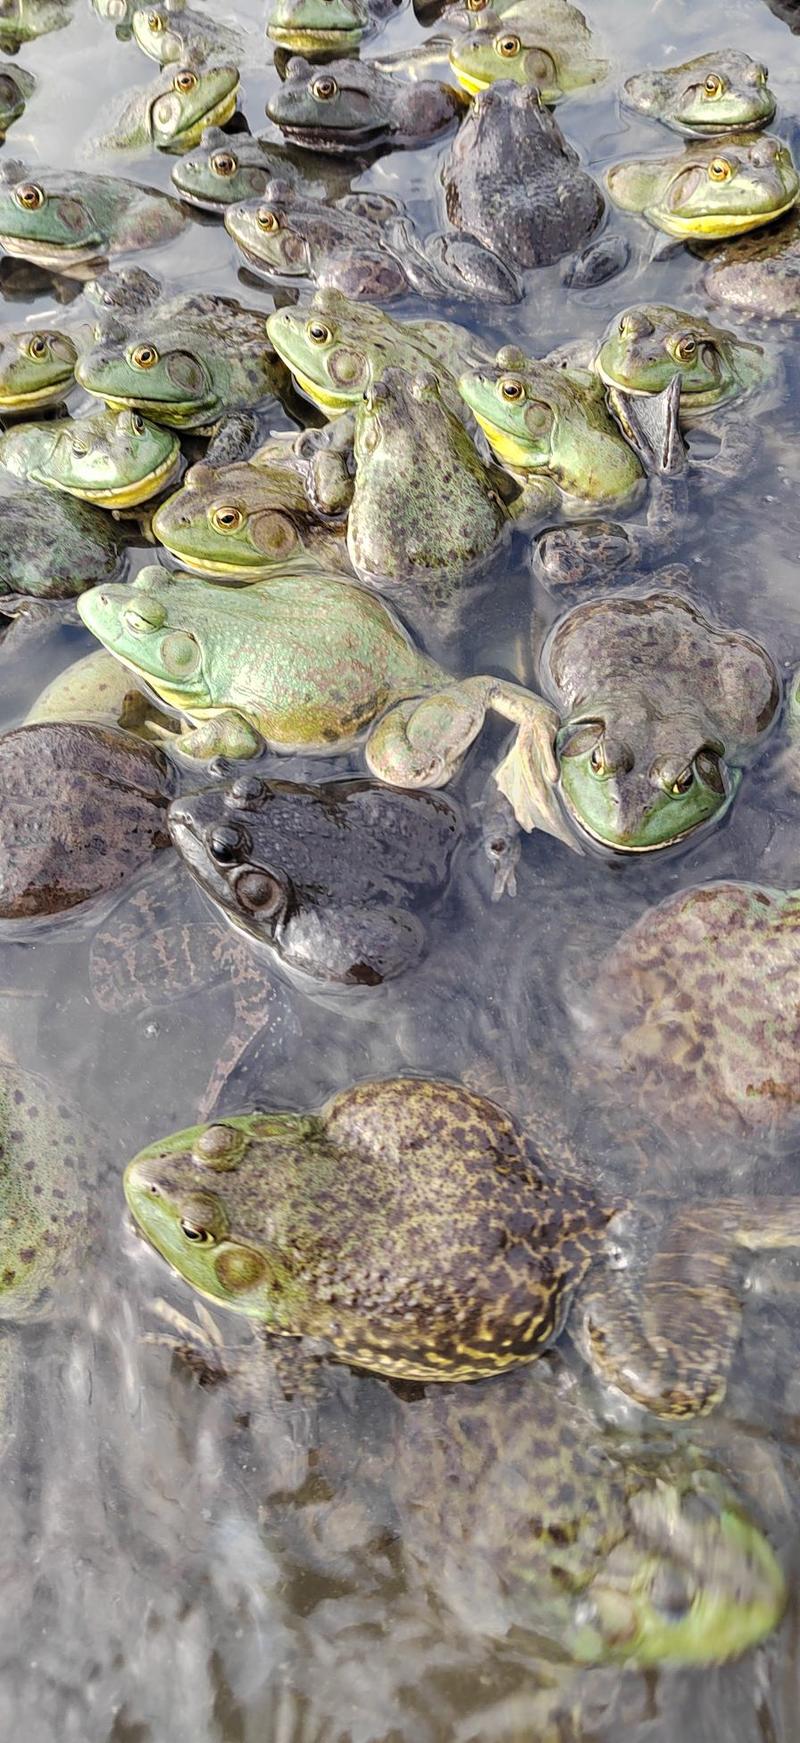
top-left (582, 882), bottom-right (800, 1136)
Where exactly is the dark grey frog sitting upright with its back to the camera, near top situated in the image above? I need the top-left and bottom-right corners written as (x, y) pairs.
top-left (441, 78), bottom-right (605, 268)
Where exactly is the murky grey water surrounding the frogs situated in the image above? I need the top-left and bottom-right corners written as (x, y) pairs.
top-left (0, 0), bottom-right (800, 1743)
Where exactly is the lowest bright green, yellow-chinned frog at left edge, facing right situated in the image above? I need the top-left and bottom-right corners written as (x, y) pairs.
top-left (0, 410), bottom-right (181, 509)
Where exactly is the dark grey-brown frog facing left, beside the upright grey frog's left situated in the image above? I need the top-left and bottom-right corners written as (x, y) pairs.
top-left (267, 56), bottom-right (463, 153)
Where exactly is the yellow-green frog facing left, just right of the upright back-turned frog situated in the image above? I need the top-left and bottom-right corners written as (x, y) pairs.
top-left (458, 345), bottom-right (643, 502)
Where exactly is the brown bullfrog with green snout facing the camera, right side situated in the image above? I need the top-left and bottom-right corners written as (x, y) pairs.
top-left (501, 589), bottom-right (781, 854)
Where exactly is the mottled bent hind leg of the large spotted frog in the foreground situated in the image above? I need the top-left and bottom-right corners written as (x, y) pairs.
top-left (573, 1197), bottom-right (800, 1417)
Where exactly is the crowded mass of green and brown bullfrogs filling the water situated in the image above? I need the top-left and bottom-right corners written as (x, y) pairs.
top-left (7, 0), bottom-right (800, 1722)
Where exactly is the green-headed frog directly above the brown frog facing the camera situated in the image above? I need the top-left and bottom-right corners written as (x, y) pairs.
top-left (594, 303), bottom-right (770, 422)
